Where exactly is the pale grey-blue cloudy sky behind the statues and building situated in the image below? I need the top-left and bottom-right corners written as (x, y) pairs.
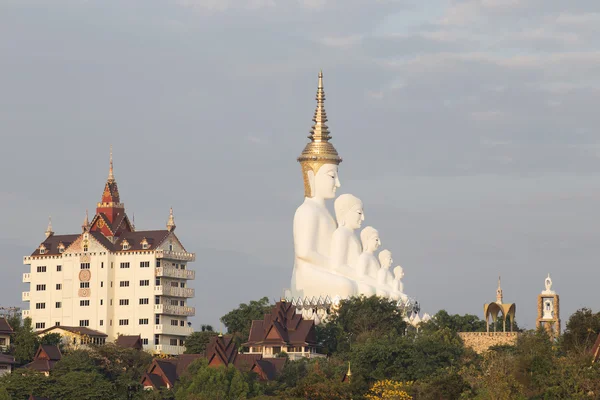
top-left (0, 0), bottom-right (600, 328)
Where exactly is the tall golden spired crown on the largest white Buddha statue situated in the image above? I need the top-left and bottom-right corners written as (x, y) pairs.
top-left (298, 71), bottom-right (342, 197)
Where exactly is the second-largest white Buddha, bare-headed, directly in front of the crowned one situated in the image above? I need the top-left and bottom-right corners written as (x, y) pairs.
top-left (330, 194), bottom-right (365, 275)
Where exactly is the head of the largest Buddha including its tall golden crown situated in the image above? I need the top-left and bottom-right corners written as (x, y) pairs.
top-left (298, 72), bottom-right (342, 199)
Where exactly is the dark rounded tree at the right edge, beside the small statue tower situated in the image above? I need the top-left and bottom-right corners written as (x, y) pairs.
top-left (562, 308), bottom-right (600, 353)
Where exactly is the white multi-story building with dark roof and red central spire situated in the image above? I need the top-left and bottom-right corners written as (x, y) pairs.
top-left (23, 152), bottom-right (195, 354)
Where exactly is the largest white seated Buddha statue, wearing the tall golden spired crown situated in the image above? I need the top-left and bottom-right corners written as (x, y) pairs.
top-left (291, 73), bottom-right (356, 298)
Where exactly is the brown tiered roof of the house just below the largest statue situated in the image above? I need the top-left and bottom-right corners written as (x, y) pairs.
top-left (244, 301), bottom-right (317, 346)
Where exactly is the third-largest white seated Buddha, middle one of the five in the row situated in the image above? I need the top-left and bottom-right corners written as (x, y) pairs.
top-left (356, 226), bottom-right (381, 296)
